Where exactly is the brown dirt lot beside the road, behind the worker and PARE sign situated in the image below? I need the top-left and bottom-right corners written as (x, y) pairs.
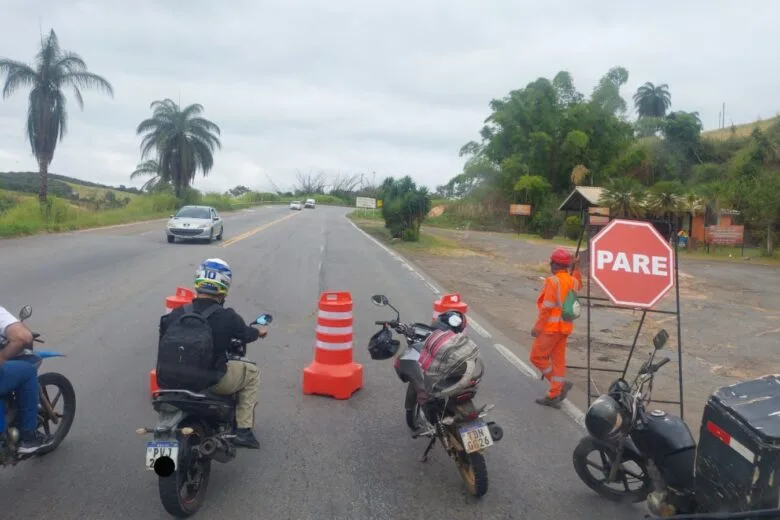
top-left (362, 223), bottom-right (780, 437)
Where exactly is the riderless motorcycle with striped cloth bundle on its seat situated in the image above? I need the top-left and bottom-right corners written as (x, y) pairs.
top-left (371, 295), bottom-right (503, 498)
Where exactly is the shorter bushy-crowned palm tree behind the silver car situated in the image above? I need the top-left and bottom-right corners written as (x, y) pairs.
top-left (136, 99), bottom-right (222, 197)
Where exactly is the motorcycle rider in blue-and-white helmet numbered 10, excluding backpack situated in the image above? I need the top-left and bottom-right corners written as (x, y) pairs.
top-left (160, 258), bottom-right (268, 449)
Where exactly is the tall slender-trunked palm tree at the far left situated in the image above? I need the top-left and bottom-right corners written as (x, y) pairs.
top-left (0, 29), bottom-right (114, 203)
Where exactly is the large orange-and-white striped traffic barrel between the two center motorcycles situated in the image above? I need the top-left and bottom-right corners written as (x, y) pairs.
top-left (303, 292), bottom-right (363, 399)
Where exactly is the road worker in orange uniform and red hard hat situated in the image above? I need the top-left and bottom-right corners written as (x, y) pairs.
top-left (530, 248), bottom-right (582, 408)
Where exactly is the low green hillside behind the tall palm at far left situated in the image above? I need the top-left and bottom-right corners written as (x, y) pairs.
top-left (0, 172), bottom-right (141, 200)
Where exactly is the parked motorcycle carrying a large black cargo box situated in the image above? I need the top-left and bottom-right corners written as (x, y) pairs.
top-left (573, 330), bottom-right (780, 519)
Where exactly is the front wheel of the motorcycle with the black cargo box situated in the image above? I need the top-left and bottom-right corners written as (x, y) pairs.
top-left (572, 437), bottom-right (652, 503)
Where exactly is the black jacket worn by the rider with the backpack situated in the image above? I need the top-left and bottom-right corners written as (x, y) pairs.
top-left (160, 298), bottom-right (260, 380)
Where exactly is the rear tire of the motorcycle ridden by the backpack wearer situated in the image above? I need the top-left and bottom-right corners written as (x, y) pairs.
top-left (157, 421), bottom-right (211, 518)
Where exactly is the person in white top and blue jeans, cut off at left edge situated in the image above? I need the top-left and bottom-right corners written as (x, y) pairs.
top-left (0, 307), bottom-right (50, 454)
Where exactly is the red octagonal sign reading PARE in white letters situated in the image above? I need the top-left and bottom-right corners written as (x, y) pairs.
top-left (590, 219), bottom-right (674, 309)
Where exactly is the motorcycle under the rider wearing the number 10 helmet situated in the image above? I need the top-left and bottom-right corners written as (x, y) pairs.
top-left (136, 314), bottom-right (273, 518)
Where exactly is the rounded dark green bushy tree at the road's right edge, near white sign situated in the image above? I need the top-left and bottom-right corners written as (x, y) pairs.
top-left (380, 175), bottom-right (431, 242)
